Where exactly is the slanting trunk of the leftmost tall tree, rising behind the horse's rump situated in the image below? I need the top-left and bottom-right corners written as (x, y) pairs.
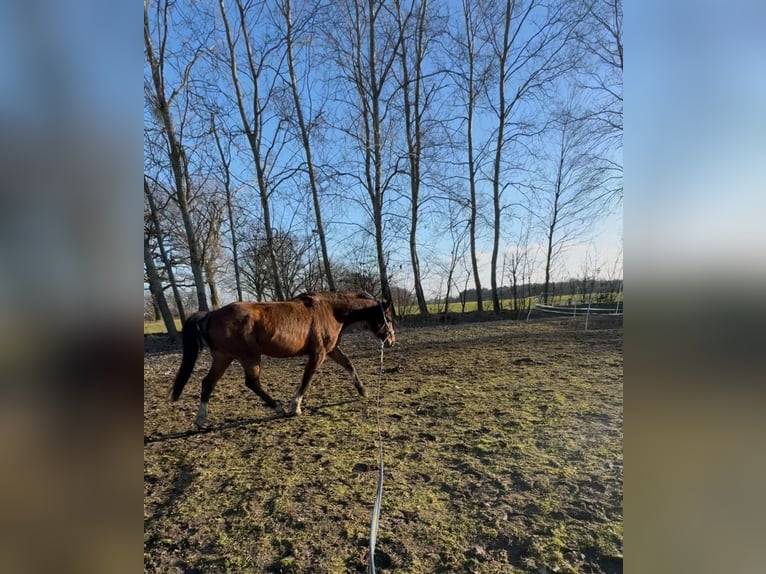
top-left (144, 0), bottom-right (208, 311)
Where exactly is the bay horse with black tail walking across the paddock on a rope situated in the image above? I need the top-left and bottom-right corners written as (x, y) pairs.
top-left (170, 292), bottom-right (396, 430)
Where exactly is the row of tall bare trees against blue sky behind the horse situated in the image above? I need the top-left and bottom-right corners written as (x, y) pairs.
top-left (144, 0), bottom-right (622, 333)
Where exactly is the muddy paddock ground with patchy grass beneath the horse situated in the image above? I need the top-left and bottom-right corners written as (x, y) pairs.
top-left (144, 319), bottom-right (623, 574)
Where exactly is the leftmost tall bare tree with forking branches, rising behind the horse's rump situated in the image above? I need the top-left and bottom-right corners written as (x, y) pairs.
top-left (144, 0), bottom-right (208, 310)
